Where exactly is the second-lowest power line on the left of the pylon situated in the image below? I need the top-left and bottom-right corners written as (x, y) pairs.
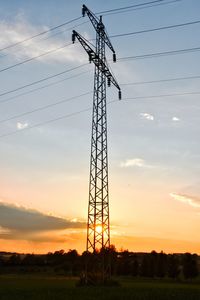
top-left (0, 91), bottom-right (92, 123)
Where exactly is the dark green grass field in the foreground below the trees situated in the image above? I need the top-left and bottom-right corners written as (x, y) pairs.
top-left (0, 275), bottom-right (200, 300)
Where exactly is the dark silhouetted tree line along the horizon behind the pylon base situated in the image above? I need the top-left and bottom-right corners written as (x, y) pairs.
top-left (0, 246), bottom-right (200, 279)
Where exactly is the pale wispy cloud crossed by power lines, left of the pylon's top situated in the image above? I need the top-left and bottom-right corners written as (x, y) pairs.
top-left (0, 15), bottom-right (84, 62)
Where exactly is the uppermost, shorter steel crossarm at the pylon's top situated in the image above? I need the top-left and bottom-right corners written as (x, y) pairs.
top-left (82, 5), bottom-right (115, 53)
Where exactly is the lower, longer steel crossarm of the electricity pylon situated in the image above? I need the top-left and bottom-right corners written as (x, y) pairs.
top-left (72, 30), bottom-right (120, 91)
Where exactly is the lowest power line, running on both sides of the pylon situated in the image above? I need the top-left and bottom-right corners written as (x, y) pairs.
top-left (0, 91), bottom-right (200, 138)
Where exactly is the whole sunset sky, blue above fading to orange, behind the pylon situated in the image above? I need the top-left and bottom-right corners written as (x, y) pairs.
top-left (0, 0), bottom-right (200, 254)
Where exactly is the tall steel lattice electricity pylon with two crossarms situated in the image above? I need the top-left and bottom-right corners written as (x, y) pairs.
top-left (72, 5), bottom-right (121, 278)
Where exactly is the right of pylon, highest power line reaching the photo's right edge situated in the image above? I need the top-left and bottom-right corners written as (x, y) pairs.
top-left (110, 20), bottom-right (200, 38)
